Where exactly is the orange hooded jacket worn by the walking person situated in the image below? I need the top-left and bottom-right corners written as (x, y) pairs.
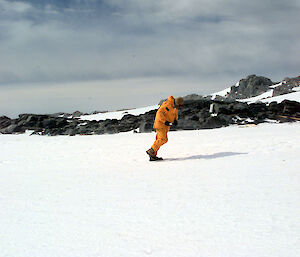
top-left (153, 96), bottom-right (178, 129)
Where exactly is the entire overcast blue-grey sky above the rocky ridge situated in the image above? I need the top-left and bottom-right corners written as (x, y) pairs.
top-left (0, 0), bottom-right (300, 117)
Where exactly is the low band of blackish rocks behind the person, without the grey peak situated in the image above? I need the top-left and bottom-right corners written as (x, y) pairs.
top-left (0, 99), bottom-right (300, 136)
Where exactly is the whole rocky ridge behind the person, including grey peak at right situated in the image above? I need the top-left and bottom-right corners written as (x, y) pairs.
top-left (0, 75), bottom-right (300, 136)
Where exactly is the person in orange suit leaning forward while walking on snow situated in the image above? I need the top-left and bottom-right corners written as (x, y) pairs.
top-left (146, 96), bottom-right (184, 160)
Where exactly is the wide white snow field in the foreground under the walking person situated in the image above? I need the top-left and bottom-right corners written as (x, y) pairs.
top-left (0, 123), bottom-right (300, 257)
